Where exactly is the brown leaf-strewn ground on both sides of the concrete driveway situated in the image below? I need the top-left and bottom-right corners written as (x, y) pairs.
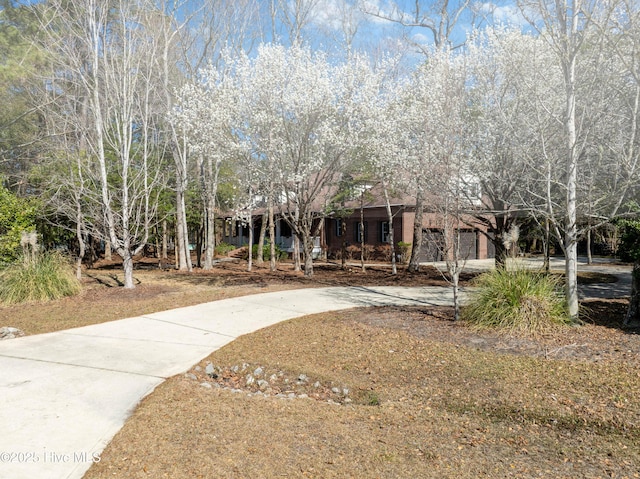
top-left (0, 263), bottom-right (640, 479)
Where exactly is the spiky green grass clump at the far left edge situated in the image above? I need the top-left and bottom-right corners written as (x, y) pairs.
top-left (0, 253), bottom-right (80, 304)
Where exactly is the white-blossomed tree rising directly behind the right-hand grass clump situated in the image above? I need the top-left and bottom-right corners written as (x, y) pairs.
top-left (465, 29), bottom-right (562, 266)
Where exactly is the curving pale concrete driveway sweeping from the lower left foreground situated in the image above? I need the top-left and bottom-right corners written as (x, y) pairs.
top-left (0, 287), bottom-right (460, 479)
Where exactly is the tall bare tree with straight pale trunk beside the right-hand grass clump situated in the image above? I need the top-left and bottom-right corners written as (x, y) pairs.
top-left (519, 0), bottom-right (635, 319)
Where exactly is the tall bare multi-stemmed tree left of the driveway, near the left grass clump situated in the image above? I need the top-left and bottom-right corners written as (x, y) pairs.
top-left (41, 0), bottom-right (168, 288)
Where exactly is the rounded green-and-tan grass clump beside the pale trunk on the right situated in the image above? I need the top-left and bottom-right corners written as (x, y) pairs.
top-left (462, 268), bottom-right (570, 335)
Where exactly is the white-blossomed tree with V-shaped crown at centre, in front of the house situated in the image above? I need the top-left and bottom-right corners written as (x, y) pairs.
top-left (237, 45), bottom-right (358, 276)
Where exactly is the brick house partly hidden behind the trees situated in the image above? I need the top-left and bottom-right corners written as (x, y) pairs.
top-left (222, 187), bottom-right (494, 262)
